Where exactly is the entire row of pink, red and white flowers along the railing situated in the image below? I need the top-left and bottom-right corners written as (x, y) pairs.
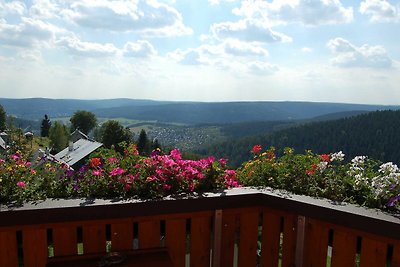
top-left (0, 145), bottom-right (400, 213)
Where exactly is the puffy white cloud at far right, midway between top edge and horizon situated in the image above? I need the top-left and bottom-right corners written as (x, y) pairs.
top-left (327, 38), bottom-right (393, 68)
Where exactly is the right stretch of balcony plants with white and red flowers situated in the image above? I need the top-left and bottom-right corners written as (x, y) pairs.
top-left (237, 145), bottom-right (400, 211)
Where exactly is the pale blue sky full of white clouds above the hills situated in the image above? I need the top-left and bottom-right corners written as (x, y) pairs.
top-left (0, 0), bottom-right (400, 105)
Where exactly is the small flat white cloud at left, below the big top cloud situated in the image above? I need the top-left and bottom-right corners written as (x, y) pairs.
top-left (56, 36), bottom-right (118, 57)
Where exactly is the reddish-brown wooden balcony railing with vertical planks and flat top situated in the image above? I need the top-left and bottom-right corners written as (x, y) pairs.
top-left (0, 188), bottom-right (400, 267)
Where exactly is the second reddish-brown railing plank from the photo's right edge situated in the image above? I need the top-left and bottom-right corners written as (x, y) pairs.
top-left (360, 237), bottom-right (387, 267)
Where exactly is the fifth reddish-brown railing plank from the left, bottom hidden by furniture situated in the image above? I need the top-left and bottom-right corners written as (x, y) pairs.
top-left (111, 220), bottom-right (133, 251)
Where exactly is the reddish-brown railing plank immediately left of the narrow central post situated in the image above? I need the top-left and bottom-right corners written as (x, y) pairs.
top-left (190, 217), bottom-right (211, 267)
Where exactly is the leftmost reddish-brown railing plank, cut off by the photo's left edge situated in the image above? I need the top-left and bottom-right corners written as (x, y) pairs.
top-left (0, 230), bottom-right (18, 267)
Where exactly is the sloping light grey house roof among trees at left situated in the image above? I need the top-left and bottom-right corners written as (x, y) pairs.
top-left (54, 139), bottom-right (103, 166)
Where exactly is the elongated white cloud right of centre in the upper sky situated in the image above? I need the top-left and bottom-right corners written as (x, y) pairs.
top-left (211, 19), bottom-right (292, 43)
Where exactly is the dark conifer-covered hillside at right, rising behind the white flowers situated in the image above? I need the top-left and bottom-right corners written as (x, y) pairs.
top-left (198, 110), bottom-right (400, 166)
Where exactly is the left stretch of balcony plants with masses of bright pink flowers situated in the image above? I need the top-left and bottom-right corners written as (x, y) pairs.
top-left (0, 145), bottom-right (238, 204)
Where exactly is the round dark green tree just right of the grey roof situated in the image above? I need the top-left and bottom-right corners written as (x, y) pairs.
top-left (100, 120), bottom-right (132, 153)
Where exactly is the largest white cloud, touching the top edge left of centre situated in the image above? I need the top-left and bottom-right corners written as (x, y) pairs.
top-left (63, 0), bottom-right (192, 36)
